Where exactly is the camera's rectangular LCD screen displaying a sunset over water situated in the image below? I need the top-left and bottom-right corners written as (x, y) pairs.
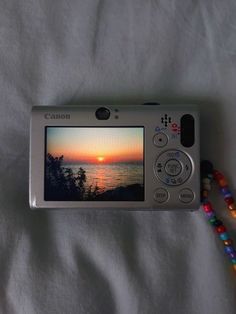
top-left (44, 126), bottom-right (144, 201)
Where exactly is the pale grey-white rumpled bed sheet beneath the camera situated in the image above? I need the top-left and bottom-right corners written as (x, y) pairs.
top-left (0, 0), bottom-right (236, 314)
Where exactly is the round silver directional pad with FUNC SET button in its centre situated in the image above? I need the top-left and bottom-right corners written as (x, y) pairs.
top-left (154, 149), bottom-right (192, 186)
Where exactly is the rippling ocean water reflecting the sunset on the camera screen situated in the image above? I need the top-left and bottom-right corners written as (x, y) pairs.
top-left (64, 163), bottom-right (143, 191)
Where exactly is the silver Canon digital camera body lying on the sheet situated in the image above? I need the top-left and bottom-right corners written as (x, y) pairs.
top-left (29, 103), bottom-right (200, 210)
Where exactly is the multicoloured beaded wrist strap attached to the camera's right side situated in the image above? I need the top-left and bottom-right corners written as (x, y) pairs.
top-left (201, 160), bottom-right (236, 271)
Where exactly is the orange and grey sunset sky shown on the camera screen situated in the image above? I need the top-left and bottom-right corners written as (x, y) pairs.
top-left (47, 127), bottom-right (143, 164)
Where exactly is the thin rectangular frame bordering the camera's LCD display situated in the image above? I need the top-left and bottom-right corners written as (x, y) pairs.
top-left (43, 125), bottom-right (146, 204)
